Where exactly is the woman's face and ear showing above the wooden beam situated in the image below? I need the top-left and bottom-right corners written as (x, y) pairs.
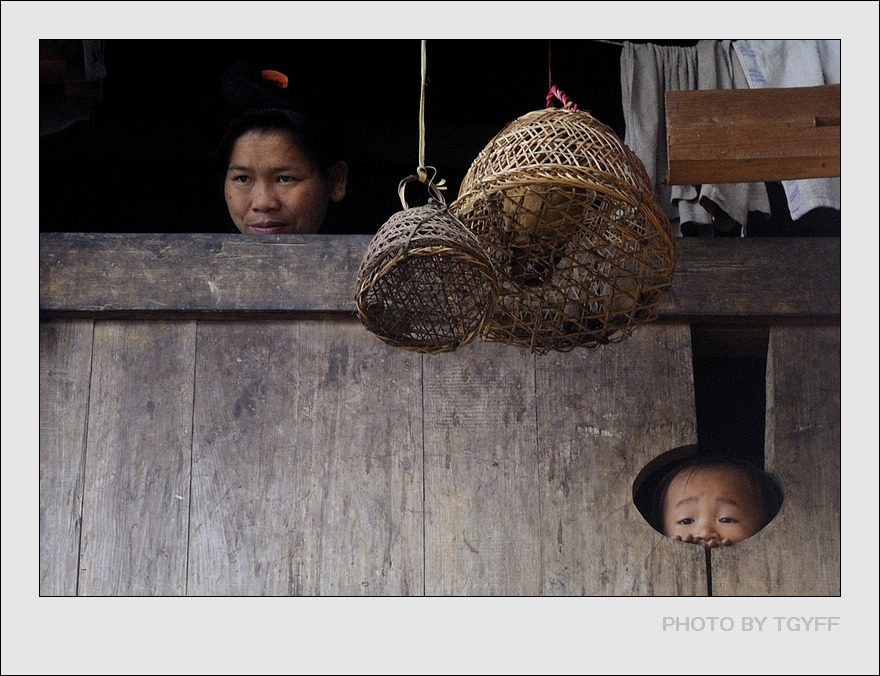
top-left (224, 130), bottom-right (348, 235)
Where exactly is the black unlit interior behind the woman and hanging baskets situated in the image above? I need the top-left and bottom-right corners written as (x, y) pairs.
top-left (40, 39), bottom-right (640, 234)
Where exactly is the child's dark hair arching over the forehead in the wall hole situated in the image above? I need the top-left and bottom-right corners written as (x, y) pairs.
top-left (645, 453), bottom-right (783, 533)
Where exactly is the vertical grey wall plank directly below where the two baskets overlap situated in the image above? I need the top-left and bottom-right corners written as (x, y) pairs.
top-left (424, 343), bottom-right (542, 596)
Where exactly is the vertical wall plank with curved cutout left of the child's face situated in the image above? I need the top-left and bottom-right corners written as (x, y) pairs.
top-left (537, 325), bottom-right (708, 596)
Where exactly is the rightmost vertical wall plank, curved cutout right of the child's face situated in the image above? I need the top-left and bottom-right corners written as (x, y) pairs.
top-left (712, 327), bottom-right (841, 596)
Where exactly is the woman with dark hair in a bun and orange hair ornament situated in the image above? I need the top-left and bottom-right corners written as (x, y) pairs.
top-left (213, 65), bottom-right (348, 235)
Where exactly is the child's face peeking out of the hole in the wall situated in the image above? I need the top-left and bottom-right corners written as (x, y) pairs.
top-left (663, 467), bottom-right (762, 547)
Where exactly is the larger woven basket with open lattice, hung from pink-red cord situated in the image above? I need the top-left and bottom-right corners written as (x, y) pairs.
top-left (450, 108), bottom-right (676, 354)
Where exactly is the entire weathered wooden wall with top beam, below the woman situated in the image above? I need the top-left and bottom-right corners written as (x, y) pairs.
top-left (40, 234), bottom-right (840, 596)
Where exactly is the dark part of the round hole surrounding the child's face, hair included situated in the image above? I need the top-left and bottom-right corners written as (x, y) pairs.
top-left (632, 444), bottom-right (783, 537)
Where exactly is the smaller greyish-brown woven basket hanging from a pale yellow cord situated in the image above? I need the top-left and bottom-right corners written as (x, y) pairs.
top-left (357, 176), bottom-right (498, 354)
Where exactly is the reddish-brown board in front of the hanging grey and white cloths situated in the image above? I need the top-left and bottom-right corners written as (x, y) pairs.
top-left (666, 84), bottom-right (840, 185)
